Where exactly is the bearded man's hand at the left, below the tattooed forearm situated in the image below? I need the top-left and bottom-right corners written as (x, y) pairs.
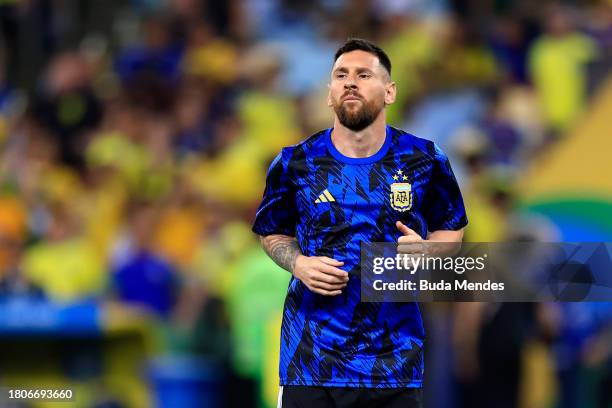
top-left (293, 255), bottom-right (349, 296)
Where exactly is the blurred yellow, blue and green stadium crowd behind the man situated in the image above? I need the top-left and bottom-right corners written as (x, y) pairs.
top-left (0, 0), bottom-right (612, 408)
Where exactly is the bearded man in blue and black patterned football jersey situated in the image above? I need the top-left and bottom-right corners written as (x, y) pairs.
top-left (253, 39), bottom-right (467, 408)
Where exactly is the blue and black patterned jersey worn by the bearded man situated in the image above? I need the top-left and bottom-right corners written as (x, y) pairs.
top-left (253, 127), bottom-right (467, 388)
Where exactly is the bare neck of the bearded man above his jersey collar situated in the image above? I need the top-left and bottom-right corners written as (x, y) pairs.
top-left (331, 110), bottom-right (387, 158)
